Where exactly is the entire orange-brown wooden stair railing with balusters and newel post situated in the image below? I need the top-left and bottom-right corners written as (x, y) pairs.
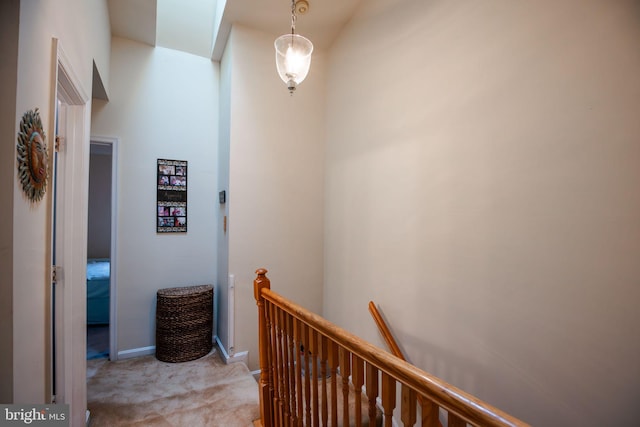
top-left (254, 269), bottom-right (527, 427)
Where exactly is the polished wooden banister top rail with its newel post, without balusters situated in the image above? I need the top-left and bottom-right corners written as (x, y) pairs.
top-left (254, 269), bottom-right (528, 427)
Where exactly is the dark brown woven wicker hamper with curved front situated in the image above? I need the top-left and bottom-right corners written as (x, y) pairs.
top-left (156, 285), bottom-right (213, 362)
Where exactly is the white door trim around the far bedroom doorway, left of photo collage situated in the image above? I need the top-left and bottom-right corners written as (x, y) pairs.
top-left (90, 136), bottom-right (120, 361)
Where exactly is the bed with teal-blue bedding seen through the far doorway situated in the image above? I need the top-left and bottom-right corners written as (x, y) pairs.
top-left (87, 258), bottom-right (111, 325)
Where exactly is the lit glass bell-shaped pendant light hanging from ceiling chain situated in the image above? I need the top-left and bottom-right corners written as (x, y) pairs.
top-left (274, 0), bottom-right (313, 94)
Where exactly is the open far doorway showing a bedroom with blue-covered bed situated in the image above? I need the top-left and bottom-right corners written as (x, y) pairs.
top-left (87, 138), bottom-right (117, 360)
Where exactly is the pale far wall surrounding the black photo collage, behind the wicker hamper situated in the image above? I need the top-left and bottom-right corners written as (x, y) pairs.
top-left (91, 38), bottom-right (219, 352)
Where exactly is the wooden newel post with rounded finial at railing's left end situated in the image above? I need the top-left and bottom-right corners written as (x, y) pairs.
top-left (253, 268), bottom-right (273, 427)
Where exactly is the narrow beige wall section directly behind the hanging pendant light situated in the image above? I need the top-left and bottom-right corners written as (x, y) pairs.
top-left (228, 26), bottom-right (325, 369)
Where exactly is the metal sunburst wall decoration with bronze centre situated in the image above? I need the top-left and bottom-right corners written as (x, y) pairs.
top-left (17, 108), bottom-right (49, 202)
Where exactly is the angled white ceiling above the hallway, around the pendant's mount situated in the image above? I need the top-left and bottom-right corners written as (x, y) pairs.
top-left (108, 0), bottom-right (362, 60)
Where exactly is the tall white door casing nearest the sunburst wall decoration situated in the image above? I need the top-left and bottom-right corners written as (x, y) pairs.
top-left (51, 38), bottom-right (91, 425)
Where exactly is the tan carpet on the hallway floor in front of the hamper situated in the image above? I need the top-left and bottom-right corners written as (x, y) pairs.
top-left (87, 349), bottom-right (260, 427)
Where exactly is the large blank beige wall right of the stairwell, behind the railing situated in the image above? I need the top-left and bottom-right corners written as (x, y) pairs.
top-left (323, 0), bottom-right (640, 426)
